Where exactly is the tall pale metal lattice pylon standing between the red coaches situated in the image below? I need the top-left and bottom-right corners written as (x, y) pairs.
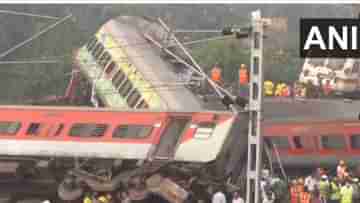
top-left (246, 10), bottom-right (263, 203)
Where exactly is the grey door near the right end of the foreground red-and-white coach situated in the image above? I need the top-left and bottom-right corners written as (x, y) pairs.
top-left (154, 117), bottom-right (191, 159)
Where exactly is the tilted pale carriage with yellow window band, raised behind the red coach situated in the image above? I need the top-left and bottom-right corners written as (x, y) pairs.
top-left (69, 16), bottom-right (204, 111)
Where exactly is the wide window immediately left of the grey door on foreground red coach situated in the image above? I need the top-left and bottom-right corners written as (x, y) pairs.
top-left (113, 125), bottom-right (152, 138)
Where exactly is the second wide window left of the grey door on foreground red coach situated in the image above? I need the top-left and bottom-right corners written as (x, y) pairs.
top-left (69, 123), bottom-right (107, 137)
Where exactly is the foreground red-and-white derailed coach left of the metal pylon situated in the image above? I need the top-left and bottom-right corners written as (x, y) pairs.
top-left (0, 106), bottom-right (248, 200)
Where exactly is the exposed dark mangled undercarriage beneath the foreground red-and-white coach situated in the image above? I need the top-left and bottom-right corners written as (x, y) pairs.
top-left (0, 157), bottom-right (245, 202)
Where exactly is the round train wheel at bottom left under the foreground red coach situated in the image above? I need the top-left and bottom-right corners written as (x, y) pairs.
top-left (58, 177), bottom-right (84, 201)
